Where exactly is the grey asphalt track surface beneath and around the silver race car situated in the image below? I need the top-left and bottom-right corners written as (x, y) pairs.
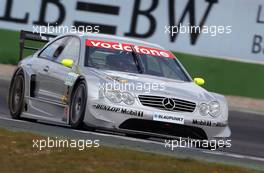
top-left (0, 79), bottom-right (264, 170)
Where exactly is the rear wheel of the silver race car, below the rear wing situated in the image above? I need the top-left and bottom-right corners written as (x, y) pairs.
top-left (8, 72), bottom-right (25, 119)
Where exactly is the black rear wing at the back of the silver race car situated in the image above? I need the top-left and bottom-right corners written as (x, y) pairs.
top-left (19, 30), bottom-right (56, 61)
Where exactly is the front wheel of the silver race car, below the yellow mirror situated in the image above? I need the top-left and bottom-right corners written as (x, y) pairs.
top-left (69, 81), bottom-right (87, 129)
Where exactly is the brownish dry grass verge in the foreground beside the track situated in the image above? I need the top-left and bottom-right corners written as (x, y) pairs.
top-left (0, 129), bottom-right (262, 173)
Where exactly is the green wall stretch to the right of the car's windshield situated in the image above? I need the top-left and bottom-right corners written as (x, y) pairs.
top-left (176, 53), bottom-right (264, 98)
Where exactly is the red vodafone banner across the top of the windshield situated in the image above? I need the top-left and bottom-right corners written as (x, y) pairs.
top-left (86, 40), bottom-right (175, 58)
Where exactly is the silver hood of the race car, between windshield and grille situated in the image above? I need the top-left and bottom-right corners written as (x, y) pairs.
top-left (86, 69), bottom-right (216, 102)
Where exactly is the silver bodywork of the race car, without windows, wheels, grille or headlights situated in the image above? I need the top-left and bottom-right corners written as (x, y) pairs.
top-left (12, 34), bottom-right (231, 139)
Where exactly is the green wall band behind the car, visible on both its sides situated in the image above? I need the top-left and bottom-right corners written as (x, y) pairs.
top-left (0, 29), bottom-right (264, 99)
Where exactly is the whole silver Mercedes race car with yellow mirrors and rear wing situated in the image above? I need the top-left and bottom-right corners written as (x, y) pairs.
top-left (8, 31), bottom-right (231, 139)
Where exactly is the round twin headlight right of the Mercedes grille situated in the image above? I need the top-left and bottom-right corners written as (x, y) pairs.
top-left (199, 101), bottom-right (220, 117)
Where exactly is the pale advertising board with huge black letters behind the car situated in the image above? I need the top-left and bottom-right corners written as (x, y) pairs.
top-left (0, 0), bottom-right (264, 63)
